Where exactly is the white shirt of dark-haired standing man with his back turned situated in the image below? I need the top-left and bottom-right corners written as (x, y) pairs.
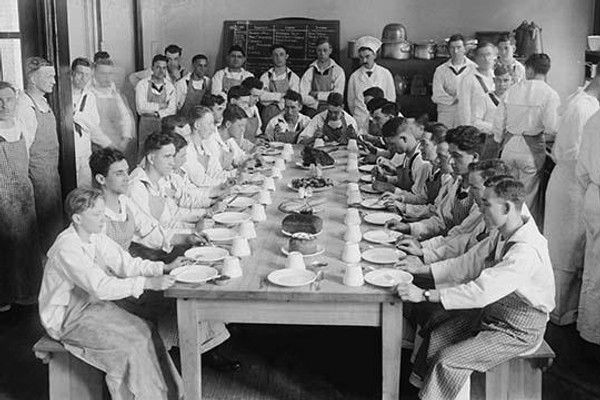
top-left (492, 79), bottom-right (560, 143)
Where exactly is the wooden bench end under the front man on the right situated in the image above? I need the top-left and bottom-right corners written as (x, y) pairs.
top-left (471, 341), bottom-right (556, 400)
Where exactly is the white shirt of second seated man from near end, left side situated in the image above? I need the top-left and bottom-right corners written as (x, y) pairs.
top-left (102, 195), bottom-right (175, 253)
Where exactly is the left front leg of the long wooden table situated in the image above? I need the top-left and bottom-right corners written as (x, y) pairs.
top-left (177, 299), bottom-right (202, 400)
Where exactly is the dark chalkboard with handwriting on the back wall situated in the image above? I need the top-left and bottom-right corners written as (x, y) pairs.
top-left (223, 18), bottom-right (340, 77)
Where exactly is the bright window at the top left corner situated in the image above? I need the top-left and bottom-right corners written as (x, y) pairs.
top-left (0, 0), bottom-right (23, 89)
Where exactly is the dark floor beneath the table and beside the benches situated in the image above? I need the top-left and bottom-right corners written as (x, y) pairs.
top-left (0, 307), bottom-right (600, 400)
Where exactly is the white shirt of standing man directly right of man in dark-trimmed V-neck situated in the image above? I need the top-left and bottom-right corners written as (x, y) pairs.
top-left (458, 69), bottom-right (500, 134)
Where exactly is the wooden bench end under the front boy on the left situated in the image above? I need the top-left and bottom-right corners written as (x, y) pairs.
top-left (33, 336), bottom-right (109, 400)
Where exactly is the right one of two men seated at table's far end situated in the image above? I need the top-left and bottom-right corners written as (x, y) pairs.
top-left (298, 92), bottom-right (358, 144)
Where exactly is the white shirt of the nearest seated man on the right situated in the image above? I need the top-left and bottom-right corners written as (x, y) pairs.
top-left (431, 218), bottom-right (555, 313)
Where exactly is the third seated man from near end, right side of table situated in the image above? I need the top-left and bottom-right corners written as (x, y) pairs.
top-left (386, 126), bottom-right (485, 240)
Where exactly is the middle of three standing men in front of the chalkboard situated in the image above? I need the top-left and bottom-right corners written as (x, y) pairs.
top-left (260, 44), bottom-right (300, 129)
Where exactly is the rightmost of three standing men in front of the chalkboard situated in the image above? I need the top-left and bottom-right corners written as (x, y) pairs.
top-left (300, 38), bottom-right (346, 118)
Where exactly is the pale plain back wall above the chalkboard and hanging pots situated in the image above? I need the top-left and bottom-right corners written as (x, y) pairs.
top-left (136, 0), bottom-right (594, 98)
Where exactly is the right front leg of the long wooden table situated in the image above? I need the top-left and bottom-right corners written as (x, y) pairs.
top-left (381, 301), bottom-right (403, 400)
